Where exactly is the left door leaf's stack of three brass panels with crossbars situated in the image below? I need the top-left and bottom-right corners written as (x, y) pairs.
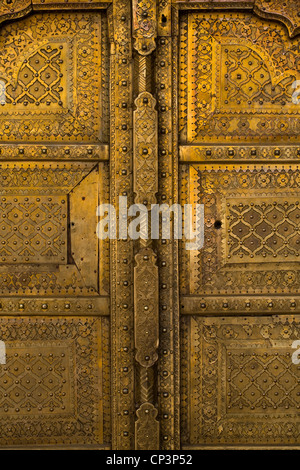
top-left (0, 7), bottom-right (111, 448)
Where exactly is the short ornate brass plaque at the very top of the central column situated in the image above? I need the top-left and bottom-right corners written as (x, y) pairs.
top-left (132, 0), bottom-right (157, 56)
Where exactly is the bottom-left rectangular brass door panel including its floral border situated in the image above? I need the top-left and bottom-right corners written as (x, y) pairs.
top-left (0, 317), bottom-right (110, 447)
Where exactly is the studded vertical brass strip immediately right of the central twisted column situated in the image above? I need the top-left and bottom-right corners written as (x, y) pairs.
top-left (155, 0), bottom-right (180, 450)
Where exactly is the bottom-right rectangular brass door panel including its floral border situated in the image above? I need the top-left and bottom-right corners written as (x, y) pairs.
top-left (182, 317), bottom-right (300, 446)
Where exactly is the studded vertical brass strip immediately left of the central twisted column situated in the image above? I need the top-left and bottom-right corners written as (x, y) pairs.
top-left (109, 0), bottom-right (135, 450)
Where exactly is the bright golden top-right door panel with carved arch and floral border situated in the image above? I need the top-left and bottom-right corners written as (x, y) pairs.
top-left (179, 12), bottom-right (300, 144)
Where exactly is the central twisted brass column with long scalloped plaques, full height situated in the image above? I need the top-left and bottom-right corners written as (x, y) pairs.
top-left (133, 0), bottom-right (159, 450)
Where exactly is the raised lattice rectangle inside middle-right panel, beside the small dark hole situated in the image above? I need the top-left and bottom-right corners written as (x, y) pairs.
top-left (225, 197), bottom-right (300, 263)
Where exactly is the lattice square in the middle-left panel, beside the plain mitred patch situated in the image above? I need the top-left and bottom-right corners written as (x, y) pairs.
top-left (0, 196), bottom-right (68, 264)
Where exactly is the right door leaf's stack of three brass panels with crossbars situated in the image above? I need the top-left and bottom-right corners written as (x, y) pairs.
top-left (179, 7), bottom-right (300, 448)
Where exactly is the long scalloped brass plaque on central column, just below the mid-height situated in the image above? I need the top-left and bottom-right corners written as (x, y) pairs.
top-left (134, 248), bottom-right (159, 368)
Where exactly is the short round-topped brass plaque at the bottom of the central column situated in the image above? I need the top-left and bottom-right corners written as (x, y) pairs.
top-left (135, 403), bottom-right (159, 450)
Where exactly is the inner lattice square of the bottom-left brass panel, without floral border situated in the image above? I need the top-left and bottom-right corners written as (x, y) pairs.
top-left (0, 342), bottom-right (74, 417)
